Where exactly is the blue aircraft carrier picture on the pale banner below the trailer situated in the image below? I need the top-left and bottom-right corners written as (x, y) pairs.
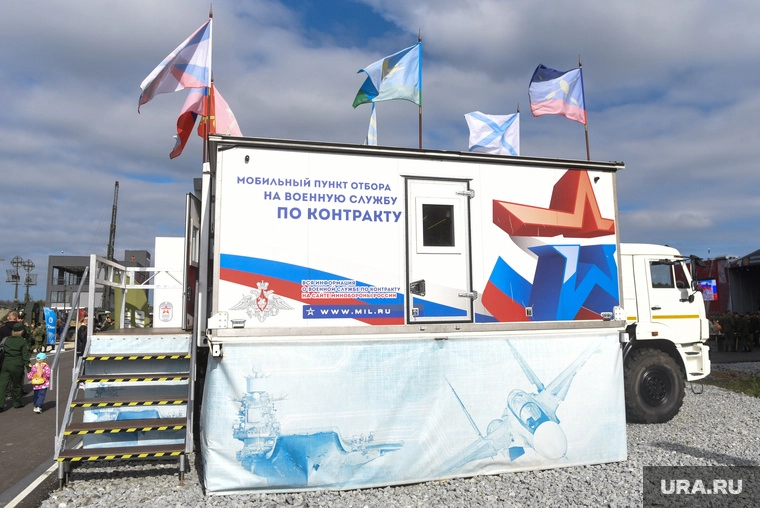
top-left (232, 370), bottom-right (403, 486)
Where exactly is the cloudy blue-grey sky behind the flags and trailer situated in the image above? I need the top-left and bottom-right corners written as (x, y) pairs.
top-left (0, 0), bottom-right (760, 299)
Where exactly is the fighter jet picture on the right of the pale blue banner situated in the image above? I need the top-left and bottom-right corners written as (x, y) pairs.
top-left (438, 340), bottom-right (599, 475)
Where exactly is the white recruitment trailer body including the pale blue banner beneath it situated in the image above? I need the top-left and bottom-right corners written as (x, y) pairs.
top-left (197, 136), bottom-right (626, 493)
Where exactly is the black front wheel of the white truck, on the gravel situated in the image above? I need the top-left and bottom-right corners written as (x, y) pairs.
top-left (624, 349), bottom-right (684, 423)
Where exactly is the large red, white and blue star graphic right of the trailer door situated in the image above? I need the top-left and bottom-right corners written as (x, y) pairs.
top-left (478, 171), bottom-right (619, 322)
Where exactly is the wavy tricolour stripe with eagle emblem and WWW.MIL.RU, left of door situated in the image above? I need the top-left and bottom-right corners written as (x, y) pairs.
top-left (219, 254), bottom-right (404, 326)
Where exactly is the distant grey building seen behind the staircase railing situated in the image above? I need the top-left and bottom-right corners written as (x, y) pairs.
top-left (45, 250), bottom-right (151, 314)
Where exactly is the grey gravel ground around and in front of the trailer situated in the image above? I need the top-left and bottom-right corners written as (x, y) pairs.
top-left (41, 363), bottom-right (760, 508)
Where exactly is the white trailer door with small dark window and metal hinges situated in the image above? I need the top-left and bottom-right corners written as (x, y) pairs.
top-left (406, 179), bottom-right (477, 323)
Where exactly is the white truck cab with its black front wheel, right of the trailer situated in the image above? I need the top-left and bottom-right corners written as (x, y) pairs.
top-left (620, 243), bottom-right (710, 423)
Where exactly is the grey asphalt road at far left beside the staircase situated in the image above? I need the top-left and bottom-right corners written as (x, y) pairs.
top-left (0, 342), bottom-right (74, 507)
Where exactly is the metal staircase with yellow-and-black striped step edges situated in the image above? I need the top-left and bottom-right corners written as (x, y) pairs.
top-left (55, 258), bottom-right (195, 488)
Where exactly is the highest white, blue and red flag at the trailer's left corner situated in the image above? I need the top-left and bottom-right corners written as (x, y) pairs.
top-left (137, 18), bottom-right (211, 112)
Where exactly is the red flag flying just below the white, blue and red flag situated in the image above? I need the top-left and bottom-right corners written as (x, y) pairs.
top-left (169, 83), bottom-right (243, 159)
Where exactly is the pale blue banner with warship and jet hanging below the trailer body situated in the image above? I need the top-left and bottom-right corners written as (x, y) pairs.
top-left (200, 328), bottom-right (626, 493)
